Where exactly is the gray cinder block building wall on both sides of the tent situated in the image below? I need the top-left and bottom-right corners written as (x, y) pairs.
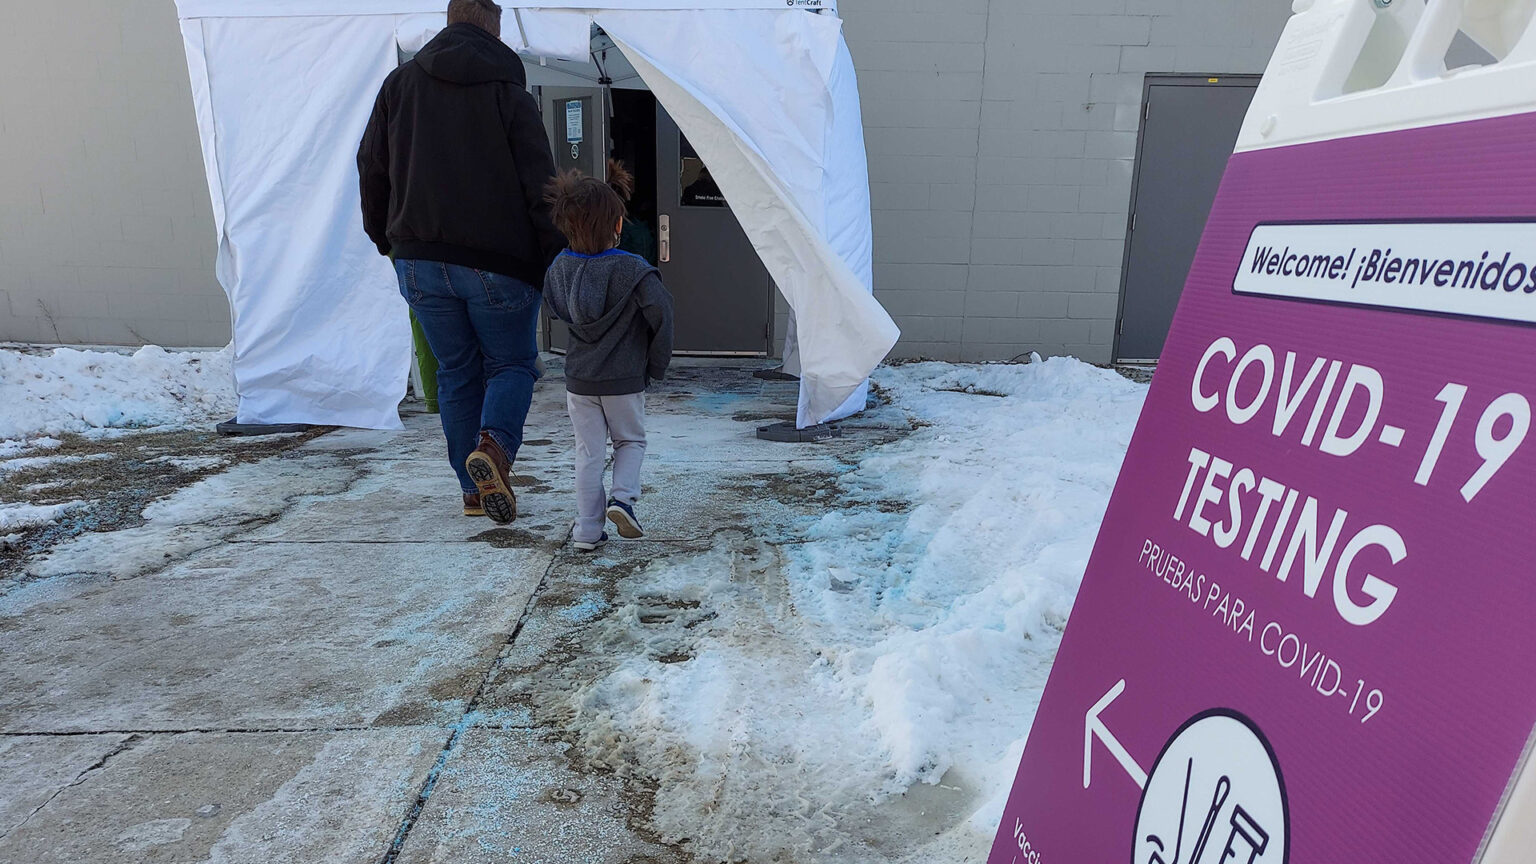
top-left (0, 0), bottom-right (1290, 356)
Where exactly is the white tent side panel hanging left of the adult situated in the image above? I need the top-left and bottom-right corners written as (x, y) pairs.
top-left (187, 15), bottom-right (410, 429)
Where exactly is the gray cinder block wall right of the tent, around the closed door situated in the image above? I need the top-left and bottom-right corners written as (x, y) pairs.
top-left (839, 0), bottom-right (1290, 363)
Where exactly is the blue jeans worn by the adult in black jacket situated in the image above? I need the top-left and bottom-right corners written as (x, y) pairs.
top-left (395, 258), bottom-right (541, 492)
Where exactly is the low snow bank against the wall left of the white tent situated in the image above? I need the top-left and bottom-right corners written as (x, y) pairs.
top-left (0, 346), bottom-right (235, 441)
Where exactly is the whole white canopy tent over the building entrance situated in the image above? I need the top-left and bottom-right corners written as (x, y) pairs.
top-left (177, 0), bottom-right (899, 429)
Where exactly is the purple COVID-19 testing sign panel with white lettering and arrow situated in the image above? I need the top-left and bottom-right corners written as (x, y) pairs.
top-left (989, 106), bottom-right (1536, 864)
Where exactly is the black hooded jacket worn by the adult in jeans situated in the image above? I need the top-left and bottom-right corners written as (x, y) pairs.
top-left (358, 23), bottom-right (565, 287)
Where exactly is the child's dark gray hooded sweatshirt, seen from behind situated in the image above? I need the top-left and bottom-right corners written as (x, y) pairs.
top-left (544, 249), bottom-right (673, 397)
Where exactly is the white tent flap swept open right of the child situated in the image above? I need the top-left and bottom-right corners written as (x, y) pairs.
top-left (598, 11), bottom-right (900, 426)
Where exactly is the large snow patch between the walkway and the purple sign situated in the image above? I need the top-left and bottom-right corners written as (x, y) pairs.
top-left (571, 358), bottom-right (1146, 864)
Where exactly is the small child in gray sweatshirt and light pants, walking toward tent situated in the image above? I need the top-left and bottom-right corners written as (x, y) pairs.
top-left (544, 161), bottom-right (673, 552)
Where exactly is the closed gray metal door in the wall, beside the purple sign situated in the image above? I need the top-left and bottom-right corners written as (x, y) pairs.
top-left (1115, 75), bottom-right (1258, 361)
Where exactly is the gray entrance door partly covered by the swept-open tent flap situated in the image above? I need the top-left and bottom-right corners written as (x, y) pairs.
top-left (656, 106), bottom-right (773, 357)
